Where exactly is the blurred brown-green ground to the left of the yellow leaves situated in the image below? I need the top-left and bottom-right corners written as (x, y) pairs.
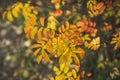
top-left (0, 0), bottom-right (53, 80)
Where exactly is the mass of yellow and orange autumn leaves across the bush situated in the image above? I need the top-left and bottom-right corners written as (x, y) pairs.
top-left (2, 0), bottom-right (120, 80)
